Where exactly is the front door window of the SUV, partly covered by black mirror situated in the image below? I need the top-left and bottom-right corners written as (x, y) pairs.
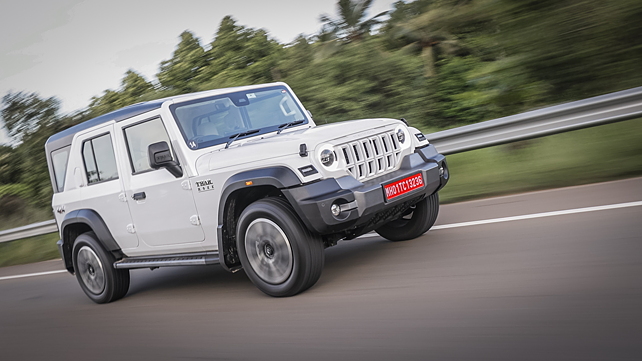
top-left (124, 118), bottom-right (173, 173)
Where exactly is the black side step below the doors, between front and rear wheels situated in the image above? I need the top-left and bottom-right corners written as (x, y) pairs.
top-left (114, 252), bottom-right (219, 269)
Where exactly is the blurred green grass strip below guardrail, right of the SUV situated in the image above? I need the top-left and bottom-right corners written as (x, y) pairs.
top-left (440, 119), bottom-right (642, 203)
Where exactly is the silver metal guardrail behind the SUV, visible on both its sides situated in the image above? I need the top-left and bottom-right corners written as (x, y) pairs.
top-left (0, 87), bottom-right (642, 243)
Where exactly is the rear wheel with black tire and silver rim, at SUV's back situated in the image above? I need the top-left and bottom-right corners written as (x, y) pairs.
top-left (72, 232), bottom-right (129, 303)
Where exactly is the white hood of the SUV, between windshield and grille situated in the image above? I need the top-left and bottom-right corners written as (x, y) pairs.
top-left (196, 118), bottom-right (402, 174)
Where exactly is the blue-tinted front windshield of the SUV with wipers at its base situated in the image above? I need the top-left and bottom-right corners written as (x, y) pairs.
top-left (170, 86), bottom-right (308, 149)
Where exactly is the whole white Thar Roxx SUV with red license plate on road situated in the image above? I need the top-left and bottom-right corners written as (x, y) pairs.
top-left (45, 83), bottom-right (448, 303)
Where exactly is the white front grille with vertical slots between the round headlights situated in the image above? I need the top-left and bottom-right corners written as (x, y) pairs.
top-left (339, 131), bottom-right (401, 181)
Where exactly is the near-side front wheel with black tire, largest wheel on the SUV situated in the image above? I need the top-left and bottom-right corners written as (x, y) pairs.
top-left (236, 197), bottom-right (325, 297)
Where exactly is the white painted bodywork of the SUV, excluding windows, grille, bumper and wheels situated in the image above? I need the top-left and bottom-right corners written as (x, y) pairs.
top-left (53, 83), bottom-right (427, 256)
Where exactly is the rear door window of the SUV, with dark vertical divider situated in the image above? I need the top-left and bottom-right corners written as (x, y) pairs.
top-left (82, 134), bottom-right (118, 184)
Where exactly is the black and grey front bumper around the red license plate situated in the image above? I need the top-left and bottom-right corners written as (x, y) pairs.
top-left (282, 145), bottom-right (449, 238)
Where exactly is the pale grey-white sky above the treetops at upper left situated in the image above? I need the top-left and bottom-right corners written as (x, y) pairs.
top-left (0, 0), bottom-right (394, 144)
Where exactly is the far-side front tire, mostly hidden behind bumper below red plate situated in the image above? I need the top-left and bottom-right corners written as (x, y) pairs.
top-left (375, 193), bottom-right (439, 242)
